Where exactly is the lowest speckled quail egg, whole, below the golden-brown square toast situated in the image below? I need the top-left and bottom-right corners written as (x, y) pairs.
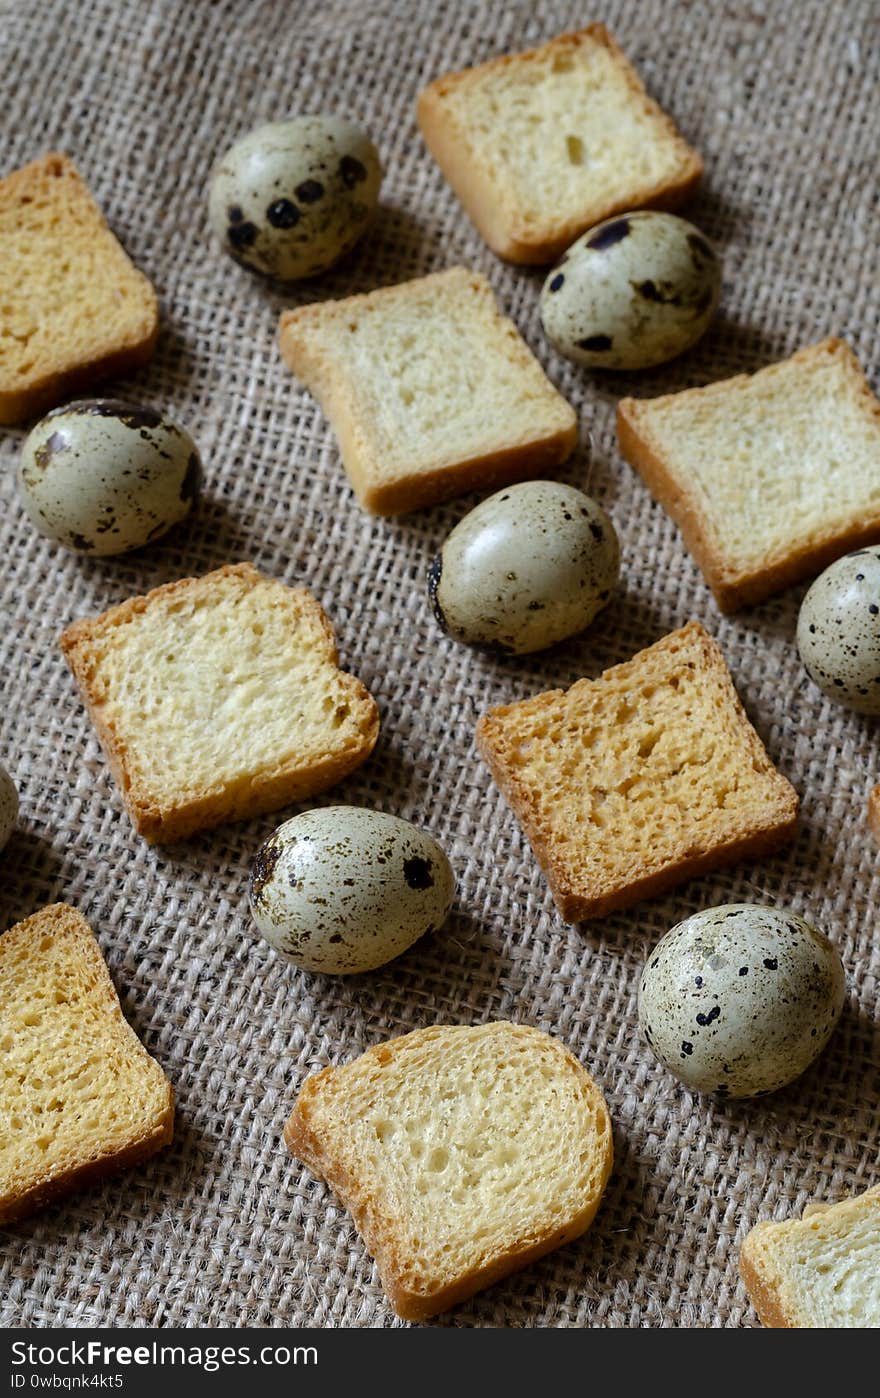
top-left (638, 903), bottom-right (844, 1097)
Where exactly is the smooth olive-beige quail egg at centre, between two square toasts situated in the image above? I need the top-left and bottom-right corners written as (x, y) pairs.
top-left (428, 481), bottom-right (620, 656)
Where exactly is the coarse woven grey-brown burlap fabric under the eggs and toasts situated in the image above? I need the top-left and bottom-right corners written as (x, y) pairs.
top-left (0, 0), bottom-right (880, 1327)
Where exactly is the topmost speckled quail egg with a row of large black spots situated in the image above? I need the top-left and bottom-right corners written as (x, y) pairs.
top-left (208, 116), bottom-right (382, 281)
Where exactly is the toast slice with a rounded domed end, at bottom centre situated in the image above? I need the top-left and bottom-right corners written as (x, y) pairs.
top-left (284, 1022), bottom-right (613, 1320)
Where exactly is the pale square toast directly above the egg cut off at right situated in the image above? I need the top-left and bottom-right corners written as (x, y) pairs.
top-left (617, 340), bottom-right (880, 612)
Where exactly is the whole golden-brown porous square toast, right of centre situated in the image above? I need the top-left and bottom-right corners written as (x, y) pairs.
top-left (477, 622), bottom-right (797, 923)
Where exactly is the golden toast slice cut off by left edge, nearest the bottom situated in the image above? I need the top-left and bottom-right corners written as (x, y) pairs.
top-left (0, 903), bottom-right (173, 1223)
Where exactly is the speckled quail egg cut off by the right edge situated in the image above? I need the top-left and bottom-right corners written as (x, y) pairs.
top-left (797, 548), bottom-right (880, 713)
